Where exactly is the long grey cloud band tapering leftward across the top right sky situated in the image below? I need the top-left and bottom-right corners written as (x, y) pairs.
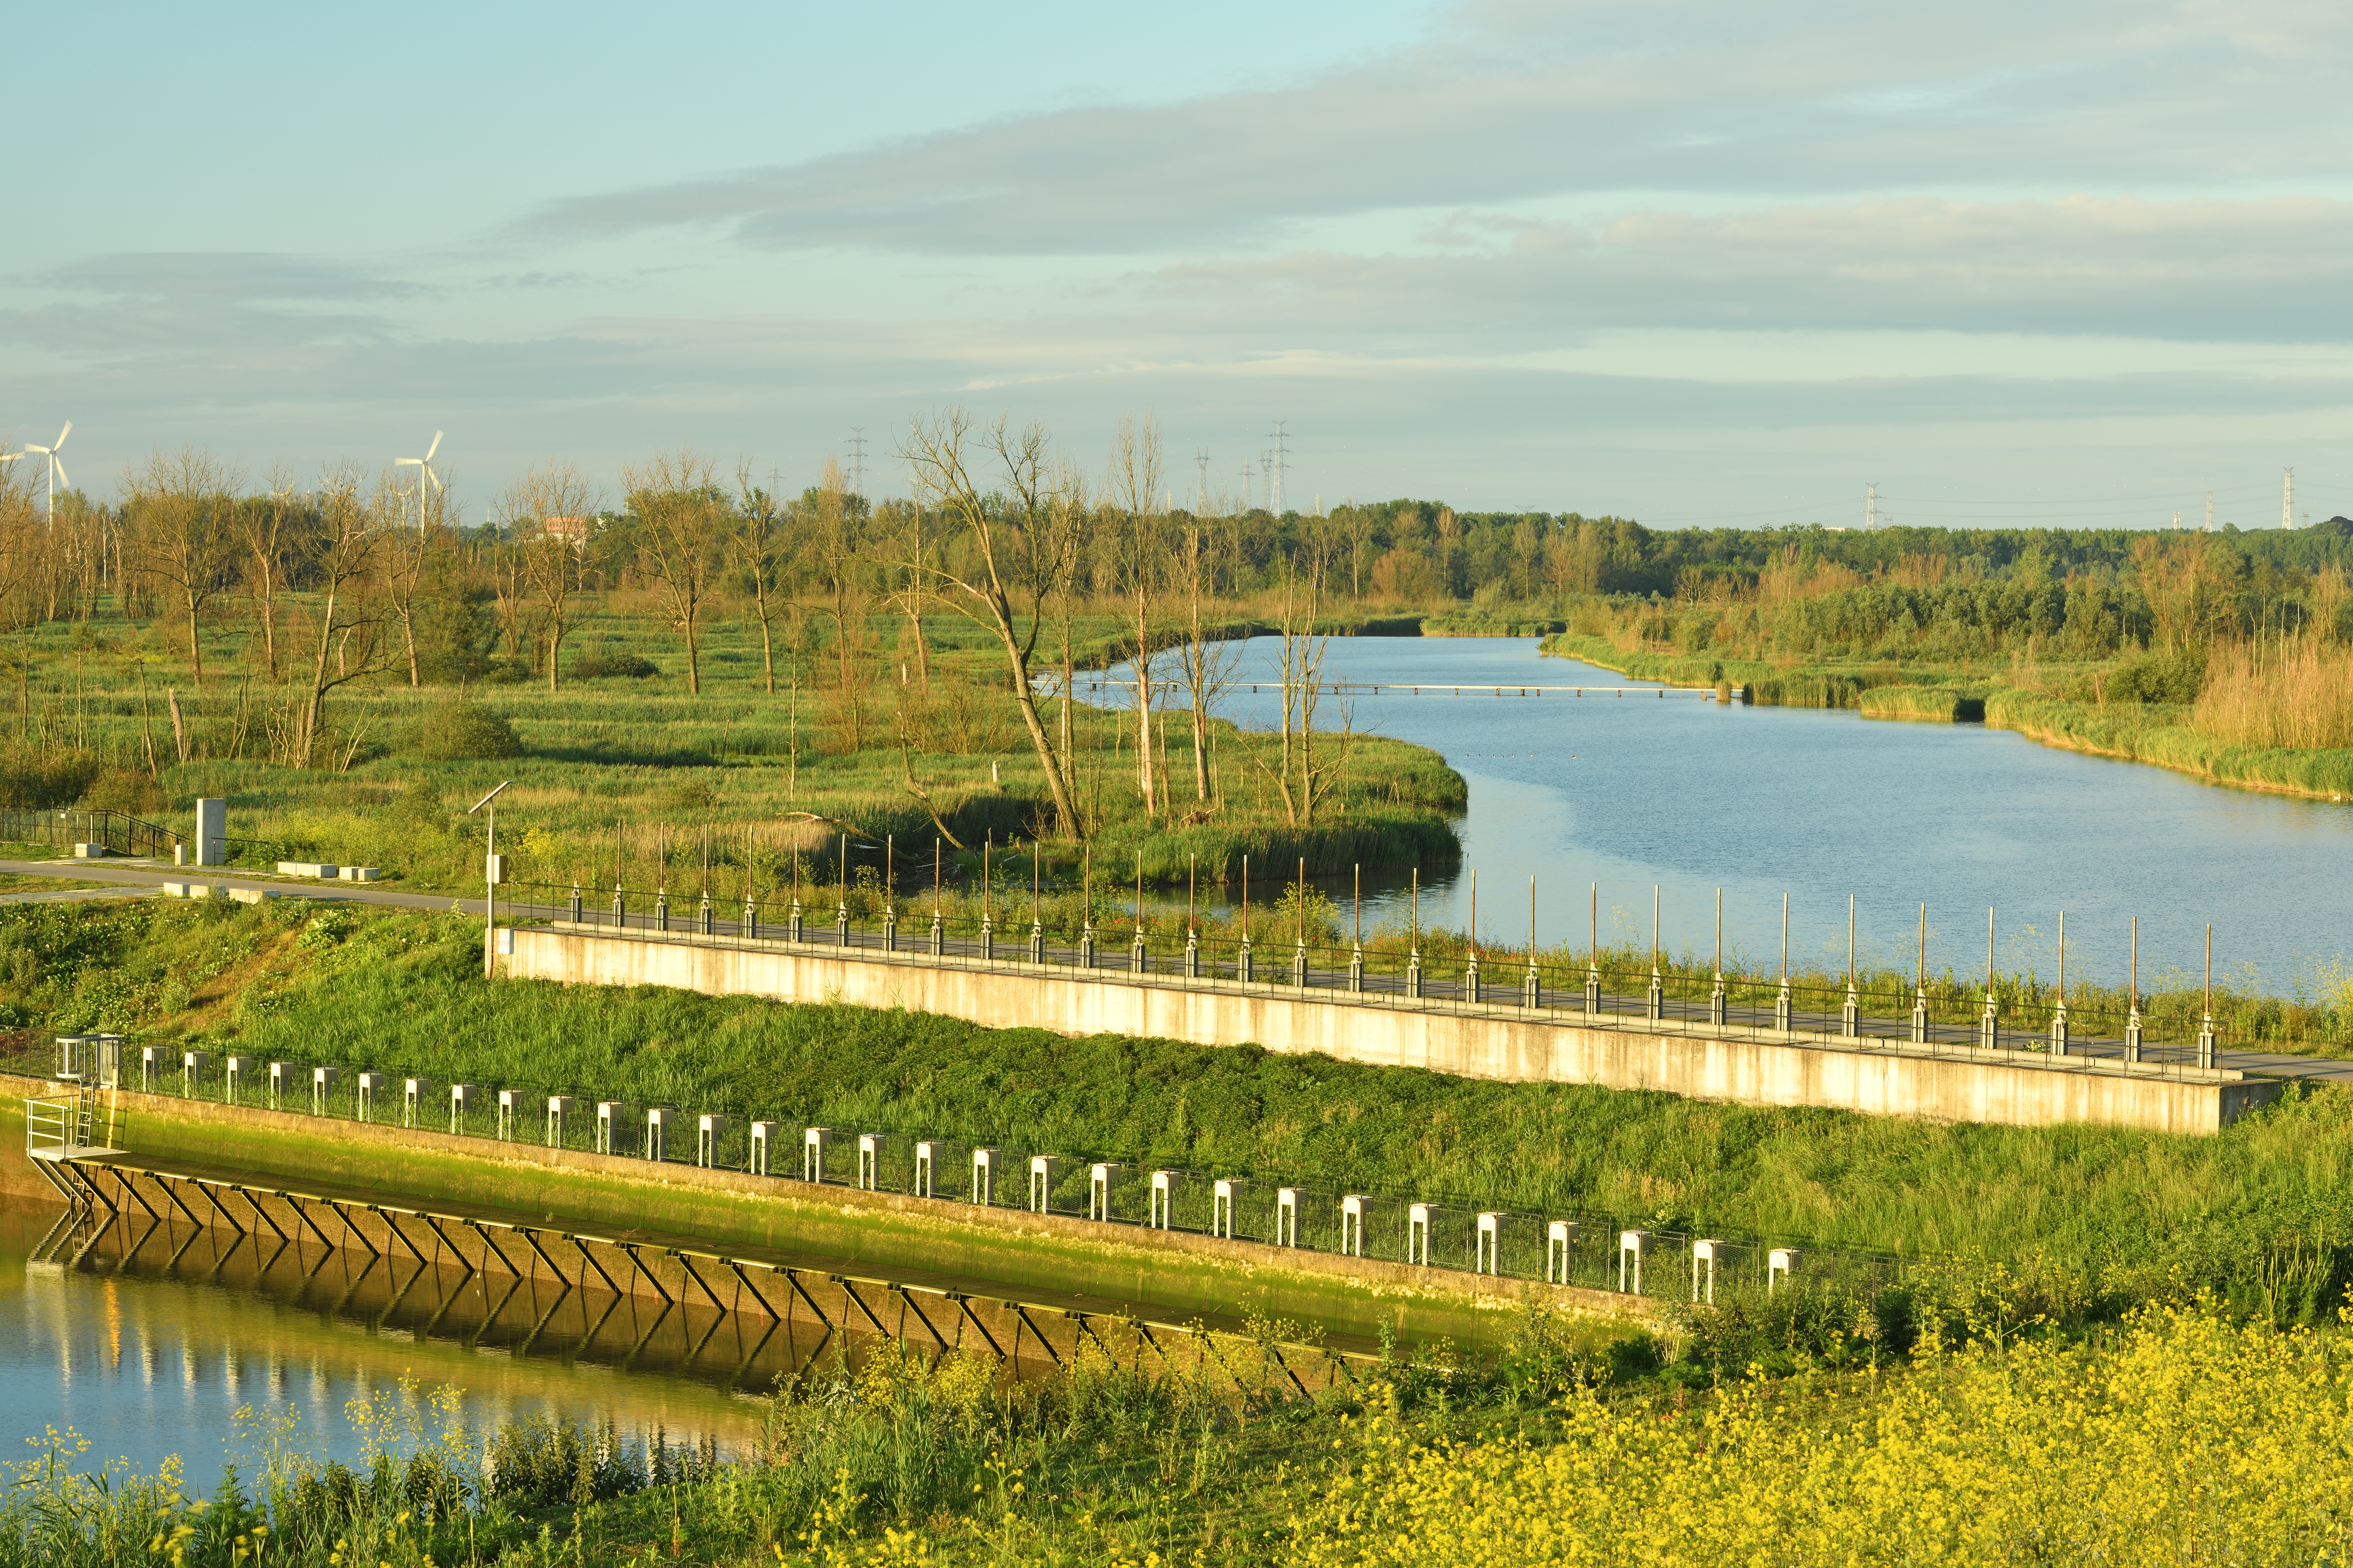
top-left (529, 5), bottom-right (2353, 256)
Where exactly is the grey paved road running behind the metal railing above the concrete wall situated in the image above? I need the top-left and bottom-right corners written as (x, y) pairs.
top-left (0, 860), bottom-right (2353, 1084)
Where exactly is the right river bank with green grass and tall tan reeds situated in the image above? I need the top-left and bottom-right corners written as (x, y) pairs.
top-left (1544, 632), bottom-right (2353, 799)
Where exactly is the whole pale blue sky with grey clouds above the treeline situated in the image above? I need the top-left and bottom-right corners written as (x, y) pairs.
top-left (0, 0), bottom-right (2353, 526)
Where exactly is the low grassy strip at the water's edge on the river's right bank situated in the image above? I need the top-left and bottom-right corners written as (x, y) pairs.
top-left (1544, 632), bottom-right (2353, 802)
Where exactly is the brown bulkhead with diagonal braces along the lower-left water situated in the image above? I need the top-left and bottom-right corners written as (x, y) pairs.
top-left (28, 1159), bottom-right (1370, 1396)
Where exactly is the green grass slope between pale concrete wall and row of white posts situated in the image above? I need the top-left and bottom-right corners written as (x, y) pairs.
top-left (0, 900), bottom-right (2353, 1319)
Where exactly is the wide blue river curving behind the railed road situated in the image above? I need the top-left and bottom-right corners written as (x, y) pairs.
top-left (1101, 637), bottom-right (2353, 992)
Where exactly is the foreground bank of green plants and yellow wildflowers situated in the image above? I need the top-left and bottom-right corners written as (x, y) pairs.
top-left (0, 1295), bottom-right (2353, 1568)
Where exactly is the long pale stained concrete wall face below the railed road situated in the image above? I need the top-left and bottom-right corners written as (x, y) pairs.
top-left (501, 926), bottom-right (2278, 1133)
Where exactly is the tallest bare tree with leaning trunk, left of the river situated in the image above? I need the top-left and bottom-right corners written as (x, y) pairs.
top-left (899, 409), bottom-right (1080, 837)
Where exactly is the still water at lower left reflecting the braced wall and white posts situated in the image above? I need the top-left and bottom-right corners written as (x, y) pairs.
top-left (0, 1206), bottom-right (771, 1491)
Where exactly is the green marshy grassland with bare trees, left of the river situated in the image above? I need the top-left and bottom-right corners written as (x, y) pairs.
top-left (5, 600), bottom-right (1466, 900)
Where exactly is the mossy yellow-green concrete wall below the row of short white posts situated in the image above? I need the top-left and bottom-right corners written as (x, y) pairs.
top-left (0, 1074), bottom-right (1652, 1347)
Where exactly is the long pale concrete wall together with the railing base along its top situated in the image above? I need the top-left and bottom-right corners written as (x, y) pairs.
top-left (496, 926), bottom-right (2283, 1133)
